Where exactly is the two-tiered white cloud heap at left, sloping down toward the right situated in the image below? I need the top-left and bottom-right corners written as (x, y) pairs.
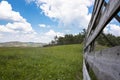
top-left (0, 1), bottom-right (35, 33)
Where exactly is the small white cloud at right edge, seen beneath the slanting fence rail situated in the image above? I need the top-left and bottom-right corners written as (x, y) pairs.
top-left (104, 24), bottom-right (120, 36)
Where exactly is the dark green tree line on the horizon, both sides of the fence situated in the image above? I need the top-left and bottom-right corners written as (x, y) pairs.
top-left (46, 31), bottom-right (120, 46)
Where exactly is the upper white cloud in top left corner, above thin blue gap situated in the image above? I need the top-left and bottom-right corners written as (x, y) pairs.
top-left (0, 1), bottom-right (26, 22)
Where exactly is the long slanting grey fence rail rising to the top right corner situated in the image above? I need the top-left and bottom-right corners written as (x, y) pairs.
top-left (86, 0), bottom-right (120, 47)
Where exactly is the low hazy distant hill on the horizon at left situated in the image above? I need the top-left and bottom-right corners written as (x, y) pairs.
top-left (0, 41), bottom-right (46, 47)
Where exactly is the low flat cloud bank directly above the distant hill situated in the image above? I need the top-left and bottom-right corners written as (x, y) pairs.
top-left (0, 30), bottom-right (64, 43)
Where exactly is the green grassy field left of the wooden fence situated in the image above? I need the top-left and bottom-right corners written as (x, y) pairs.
top-left (0, 44), bottom-right (83, 80)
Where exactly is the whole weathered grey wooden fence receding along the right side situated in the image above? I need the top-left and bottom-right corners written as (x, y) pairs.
top-left (83, 0), bottom-right (120, 80)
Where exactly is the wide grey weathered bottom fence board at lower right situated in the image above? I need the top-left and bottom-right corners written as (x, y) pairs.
top-left (86, 46), bottom-right (120, 80)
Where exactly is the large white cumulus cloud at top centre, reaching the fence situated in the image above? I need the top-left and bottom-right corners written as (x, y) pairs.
top-left (27, 0), bottom-right (94, 28)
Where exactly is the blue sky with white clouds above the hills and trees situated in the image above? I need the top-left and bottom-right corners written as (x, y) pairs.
top-left (0, 0), bottom-right (120, 43)
